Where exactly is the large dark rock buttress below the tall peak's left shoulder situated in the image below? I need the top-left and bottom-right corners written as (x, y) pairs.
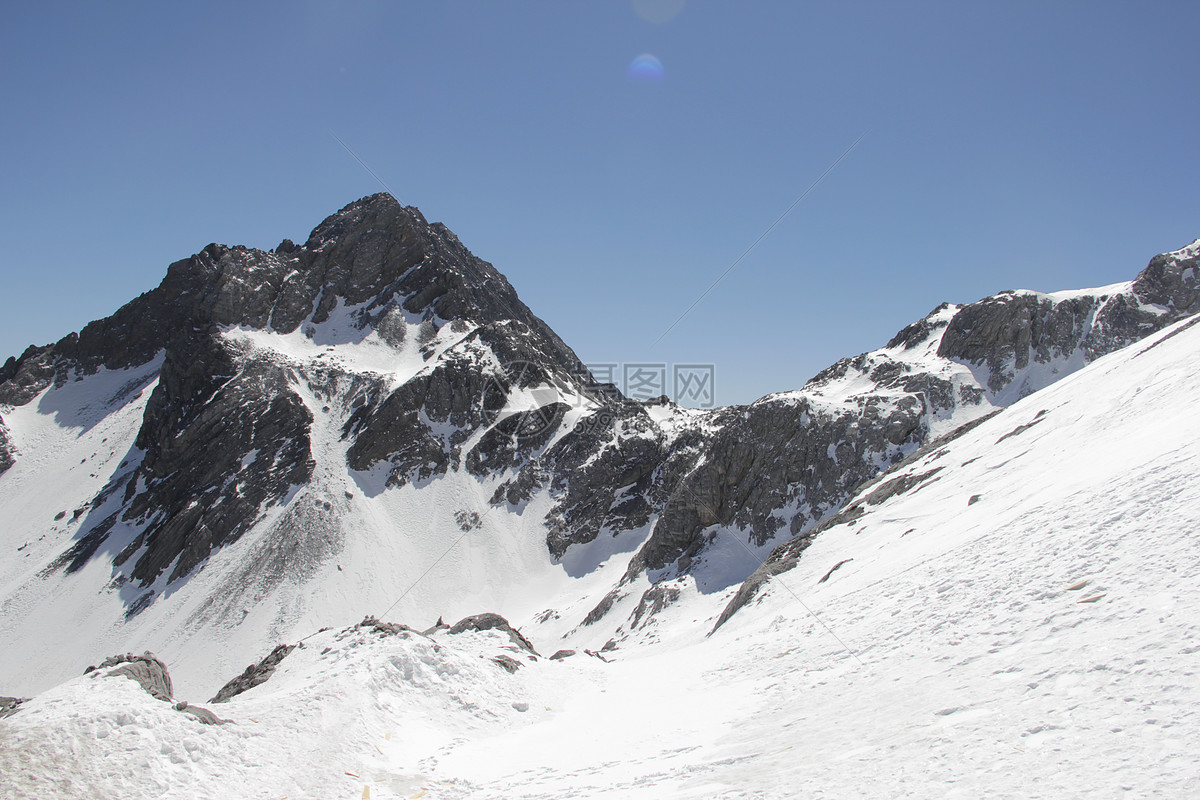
top-left (112, 335), bottom-right (313, 584)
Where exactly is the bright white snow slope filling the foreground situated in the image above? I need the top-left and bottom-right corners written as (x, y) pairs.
top-left (0, 272), bottom-right (1200, 799)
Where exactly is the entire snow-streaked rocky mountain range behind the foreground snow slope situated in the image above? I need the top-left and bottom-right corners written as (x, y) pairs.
top-left (0, 196), bottom-right (1200, 710)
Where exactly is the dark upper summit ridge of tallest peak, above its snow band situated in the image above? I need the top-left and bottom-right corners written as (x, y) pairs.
top-left (0, 193), bottom-right (577, 405)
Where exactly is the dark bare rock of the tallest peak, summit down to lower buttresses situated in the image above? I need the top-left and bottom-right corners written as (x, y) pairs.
top-left (0, 196), bottom-right (600, 594)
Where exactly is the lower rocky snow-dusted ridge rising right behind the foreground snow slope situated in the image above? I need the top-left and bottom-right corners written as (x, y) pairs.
top-left (609, 242), bottom-right (1200, 604)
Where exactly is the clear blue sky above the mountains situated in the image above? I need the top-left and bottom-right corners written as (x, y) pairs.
top-left (0, 0), bottom-right (1200, 403)
